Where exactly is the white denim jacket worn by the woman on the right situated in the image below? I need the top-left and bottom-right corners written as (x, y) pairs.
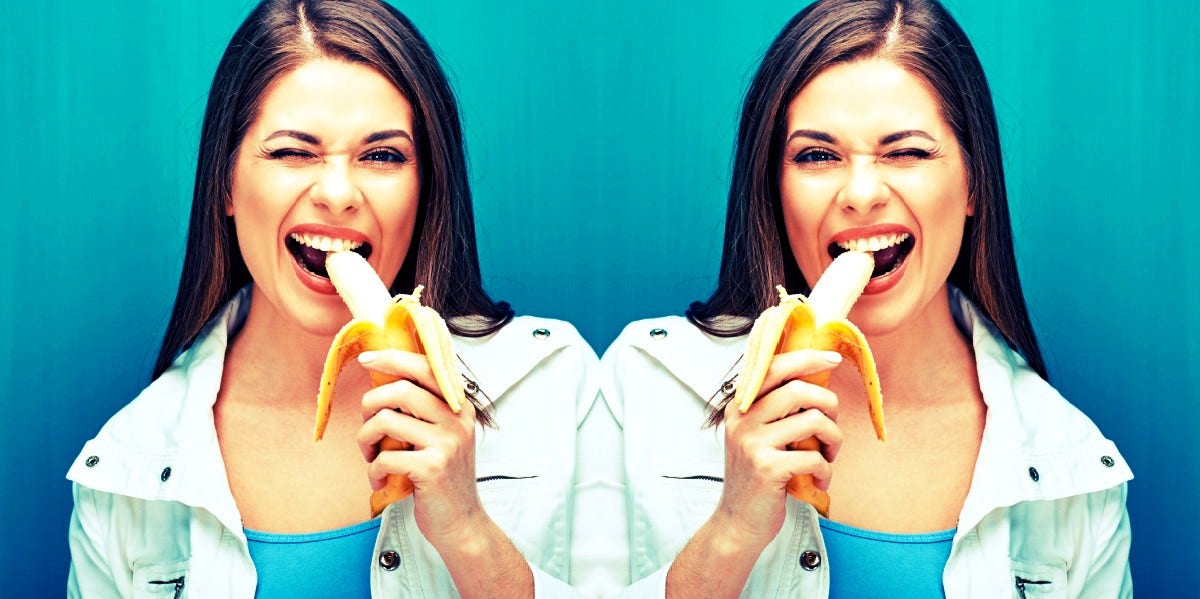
top-left (598, 288), bottom-right (1133, 599)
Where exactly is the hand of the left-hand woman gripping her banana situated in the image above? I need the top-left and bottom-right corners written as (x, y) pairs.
top-left (358, 349), bottom-right (493, 549)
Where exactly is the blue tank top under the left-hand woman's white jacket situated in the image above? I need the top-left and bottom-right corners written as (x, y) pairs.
top-left (245, 519), bottom-right (379, 599)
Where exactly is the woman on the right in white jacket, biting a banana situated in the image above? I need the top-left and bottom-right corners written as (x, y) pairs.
top-left (601, 0), bottom-right (1132, 597)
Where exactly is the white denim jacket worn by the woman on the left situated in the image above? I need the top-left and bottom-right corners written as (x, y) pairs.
top-left (67, 288), bottom-right (598, 599)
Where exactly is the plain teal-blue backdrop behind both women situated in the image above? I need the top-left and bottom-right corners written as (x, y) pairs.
top-left (0, 0), bottom-right (1200, 597)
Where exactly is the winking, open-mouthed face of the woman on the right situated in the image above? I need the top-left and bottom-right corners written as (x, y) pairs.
top-left (780, 59), bottom-right (972, 335)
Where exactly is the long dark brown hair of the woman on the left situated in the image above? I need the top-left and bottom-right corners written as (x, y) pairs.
top-left (152, 0), bottom-right (512, 377)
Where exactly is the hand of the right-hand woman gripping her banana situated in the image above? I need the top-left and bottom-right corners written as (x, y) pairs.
top-left (714, 349), bottom-right (842, 547)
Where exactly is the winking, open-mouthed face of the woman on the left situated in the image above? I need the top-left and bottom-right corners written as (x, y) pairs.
top-left (226, 59), bottom-right (420, 335)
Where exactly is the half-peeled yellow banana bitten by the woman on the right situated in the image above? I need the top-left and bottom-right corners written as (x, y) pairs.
top-left (733, 252), bottom-right (887, 516)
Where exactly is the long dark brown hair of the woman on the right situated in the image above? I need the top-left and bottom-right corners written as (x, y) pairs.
top-left (688, 0), bottom-right (1046, 378)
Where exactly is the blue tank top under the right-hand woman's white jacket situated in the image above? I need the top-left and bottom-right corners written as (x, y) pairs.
top-left (821, 519), bottom-right (954, 599)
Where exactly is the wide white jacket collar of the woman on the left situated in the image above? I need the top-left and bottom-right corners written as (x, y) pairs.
top-left (67, 286), bottom-right (568, 534)
